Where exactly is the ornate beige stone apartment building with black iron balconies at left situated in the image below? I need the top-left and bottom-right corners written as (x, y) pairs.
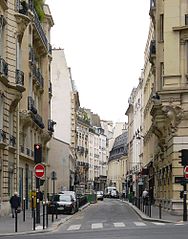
top-left (0, 0), bottom-right (53, 215)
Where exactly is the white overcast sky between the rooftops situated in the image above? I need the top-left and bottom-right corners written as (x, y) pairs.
top-left (45, 0), bottom-right (150, 122)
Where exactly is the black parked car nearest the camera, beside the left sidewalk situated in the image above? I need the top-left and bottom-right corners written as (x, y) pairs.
top-left (48, 194), bottom-right (76, 214)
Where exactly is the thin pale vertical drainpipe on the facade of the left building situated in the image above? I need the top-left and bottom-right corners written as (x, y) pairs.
top-left (16, 103), bottom-right (20, 192)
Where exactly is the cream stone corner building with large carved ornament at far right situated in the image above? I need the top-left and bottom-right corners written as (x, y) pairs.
top-left (150, 0), bottom-right (188, 213)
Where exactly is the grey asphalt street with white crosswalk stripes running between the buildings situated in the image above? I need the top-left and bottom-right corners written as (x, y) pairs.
top-left (1, 198), bottom-right (188, 239)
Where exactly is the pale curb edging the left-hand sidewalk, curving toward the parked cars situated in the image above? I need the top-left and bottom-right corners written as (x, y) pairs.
top-left (0, 203), bottom-right (90, 237)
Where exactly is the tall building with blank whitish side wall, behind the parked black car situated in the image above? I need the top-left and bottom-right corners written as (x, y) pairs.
top-left (47, 48), bottom-right (79, 193)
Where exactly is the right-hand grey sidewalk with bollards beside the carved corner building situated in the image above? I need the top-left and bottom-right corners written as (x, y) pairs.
top-left (123, 201), bottom-right (183, 223)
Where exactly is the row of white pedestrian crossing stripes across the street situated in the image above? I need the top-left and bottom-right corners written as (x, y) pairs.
top-left (66, 221), bottom-right (169, 231)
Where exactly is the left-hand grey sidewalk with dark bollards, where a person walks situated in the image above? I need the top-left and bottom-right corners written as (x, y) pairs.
top-left (0, 203), bottom-right (89, 237)
